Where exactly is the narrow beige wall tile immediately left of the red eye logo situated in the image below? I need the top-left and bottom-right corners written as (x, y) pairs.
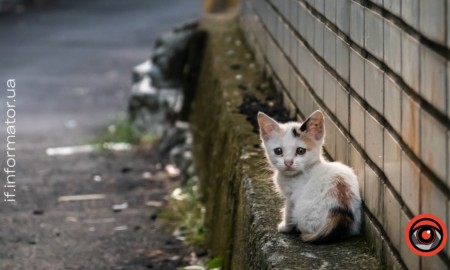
top-left (383, 185), bottom-right (404, 250)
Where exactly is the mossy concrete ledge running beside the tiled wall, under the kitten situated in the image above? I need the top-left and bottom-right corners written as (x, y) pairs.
top-left (191, 16), bottom-right (384, 270)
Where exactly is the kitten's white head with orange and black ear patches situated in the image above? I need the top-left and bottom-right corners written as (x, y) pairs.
top-left (258, 111), bottom-right (325, 176)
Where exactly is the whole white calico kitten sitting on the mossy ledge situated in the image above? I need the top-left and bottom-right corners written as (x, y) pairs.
top-left (258, 111), bottom-right (361, 243)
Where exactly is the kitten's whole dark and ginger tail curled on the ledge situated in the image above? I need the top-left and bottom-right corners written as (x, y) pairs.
top-left (301, 207), bottom-right (355, 244)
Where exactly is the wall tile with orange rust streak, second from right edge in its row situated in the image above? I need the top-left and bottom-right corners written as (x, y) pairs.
top-left (401, 92), bottom-right (420, 156)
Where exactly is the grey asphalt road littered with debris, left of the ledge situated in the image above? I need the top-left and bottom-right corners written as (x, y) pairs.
top-left (0, 0), bottom-right (202, 270)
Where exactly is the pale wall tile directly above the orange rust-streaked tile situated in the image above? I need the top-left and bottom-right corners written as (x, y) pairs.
top-left (402, 32), bottom-right (419, 93)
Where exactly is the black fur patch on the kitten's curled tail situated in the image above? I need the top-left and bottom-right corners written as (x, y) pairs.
top-left (314, 207), bottom-right (355, 244)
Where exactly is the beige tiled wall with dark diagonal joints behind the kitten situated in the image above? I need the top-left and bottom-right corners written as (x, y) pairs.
top-left (240, 0), bottom-right (450, 269)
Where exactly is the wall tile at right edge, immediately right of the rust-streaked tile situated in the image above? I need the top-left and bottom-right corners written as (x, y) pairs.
top-left (420, 110), bottom-right (447, 181)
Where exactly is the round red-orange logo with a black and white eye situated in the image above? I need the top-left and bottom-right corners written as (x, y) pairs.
top-left (405, 214), bottom-right (447, 256)
